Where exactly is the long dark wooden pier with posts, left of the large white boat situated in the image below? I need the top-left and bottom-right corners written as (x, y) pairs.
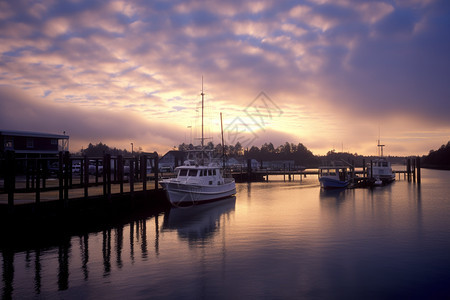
top-left (0, 151), bottom-right (168, 217)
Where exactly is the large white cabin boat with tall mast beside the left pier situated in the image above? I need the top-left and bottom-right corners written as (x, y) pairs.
top-left (160, 79), bottom-right (236, 206)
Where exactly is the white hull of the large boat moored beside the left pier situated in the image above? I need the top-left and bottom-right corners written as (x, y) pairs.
top-left (161, 181), bottom-right (236, 206)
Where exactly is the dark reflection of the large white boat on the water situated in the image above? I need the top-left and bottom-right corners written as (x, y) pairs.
top-left (162, 197), bottom-right (236, 242)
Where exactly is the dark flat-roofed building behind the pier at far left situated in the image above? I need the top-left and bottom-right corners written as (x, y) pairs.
top-left (0, 130), bottom-right (69, 158)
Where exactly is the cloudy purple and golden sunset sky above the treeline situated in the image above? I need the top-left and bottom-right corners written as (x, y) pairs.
top-left (0, 0), bottom-right (450, 155)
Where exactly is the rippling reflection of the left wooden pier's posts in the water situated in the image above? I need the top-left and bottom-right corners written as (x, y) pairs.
top-left (0, 212), bottom-right (165, 299)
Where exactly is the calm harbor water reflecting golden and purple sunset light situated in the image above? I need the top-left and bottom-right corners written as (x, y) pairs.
top-left (1, 170), bottom-right (450, 299)
